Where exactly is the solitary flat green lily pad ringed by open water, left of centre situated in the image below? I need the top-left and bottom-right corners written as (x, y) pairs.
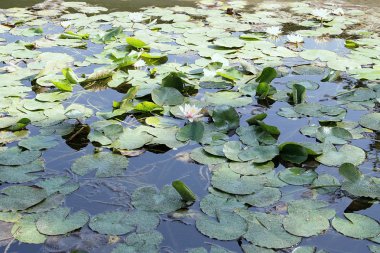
top-left (71, 152), bottom-right (128, 177)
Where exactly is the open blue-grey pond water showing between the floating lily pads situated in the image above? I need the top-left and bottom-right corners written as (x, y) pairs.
top-left (0, 0), bottom-right (380, 253)
